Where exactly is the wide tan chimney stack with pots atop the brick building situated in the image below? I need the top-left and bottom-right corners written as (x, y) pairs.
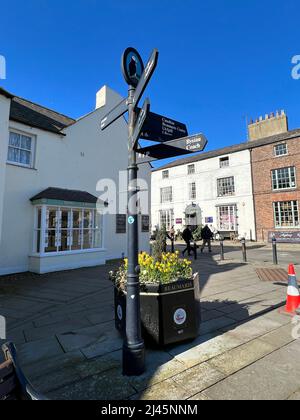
top-left (248, 111), bottom-right (288, 141)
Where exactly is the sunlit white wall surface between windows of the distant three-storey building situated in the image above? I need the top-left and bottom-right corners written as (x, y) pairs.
top-left (151, 150), bottom-right (255, 240)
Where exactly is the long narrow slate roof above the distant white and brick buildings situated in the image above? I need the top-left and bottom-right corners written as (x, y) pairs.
top-left (152, 129), bottom-right (300, 172)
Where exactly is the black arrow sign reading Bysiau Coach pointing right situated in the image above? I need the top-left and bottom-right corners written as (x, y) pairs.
top-left (137, 134), bottom-right (208, 164)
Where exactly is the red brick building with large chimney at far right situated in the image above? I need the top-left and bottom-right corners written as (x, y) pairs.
top-left (249, 112), bottom-right (300, 243)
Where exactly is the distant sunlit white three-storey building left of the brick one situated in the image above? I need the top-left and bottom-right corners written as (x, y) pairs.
top-left (151, 143), bottom-right (255, 240)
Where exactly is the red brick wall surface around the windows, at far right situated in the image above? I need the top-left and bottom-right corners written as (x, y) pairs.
top-left (252, 137), bottom-right (300, 241)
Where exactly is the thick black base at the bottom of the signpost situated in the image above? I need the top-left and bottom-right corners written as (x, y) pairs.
top-left (123, 342), bottom-right (145, 376)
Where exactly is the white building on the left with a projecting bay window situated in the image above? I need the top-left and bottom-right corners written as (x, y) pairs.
top-left (0, 87), bottom-right (150, 275)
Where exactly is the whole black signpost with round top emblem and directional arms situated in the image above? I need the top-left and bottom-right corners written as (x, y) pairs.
top-left (101, 48), bottom-right (207, 376)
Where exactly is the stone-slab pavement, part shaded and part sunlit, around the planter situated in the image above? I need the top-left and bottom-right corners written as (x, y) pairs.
top-left (0, 254), bottom-right (300, 400)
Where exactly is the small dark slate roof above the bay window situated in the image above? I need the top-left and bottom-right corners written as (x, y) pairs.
top-left (30, 187), bottom-right (98, 204)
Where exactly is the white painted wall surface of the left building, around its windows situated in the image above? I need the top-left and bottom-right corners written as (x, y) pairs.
top-left (0, 88), bottom-right (150, 275)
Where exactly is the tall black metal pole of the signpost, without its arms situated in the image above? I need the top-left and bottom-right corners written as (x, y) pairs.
top-left (123, 86), bottom-right (145, 376)
